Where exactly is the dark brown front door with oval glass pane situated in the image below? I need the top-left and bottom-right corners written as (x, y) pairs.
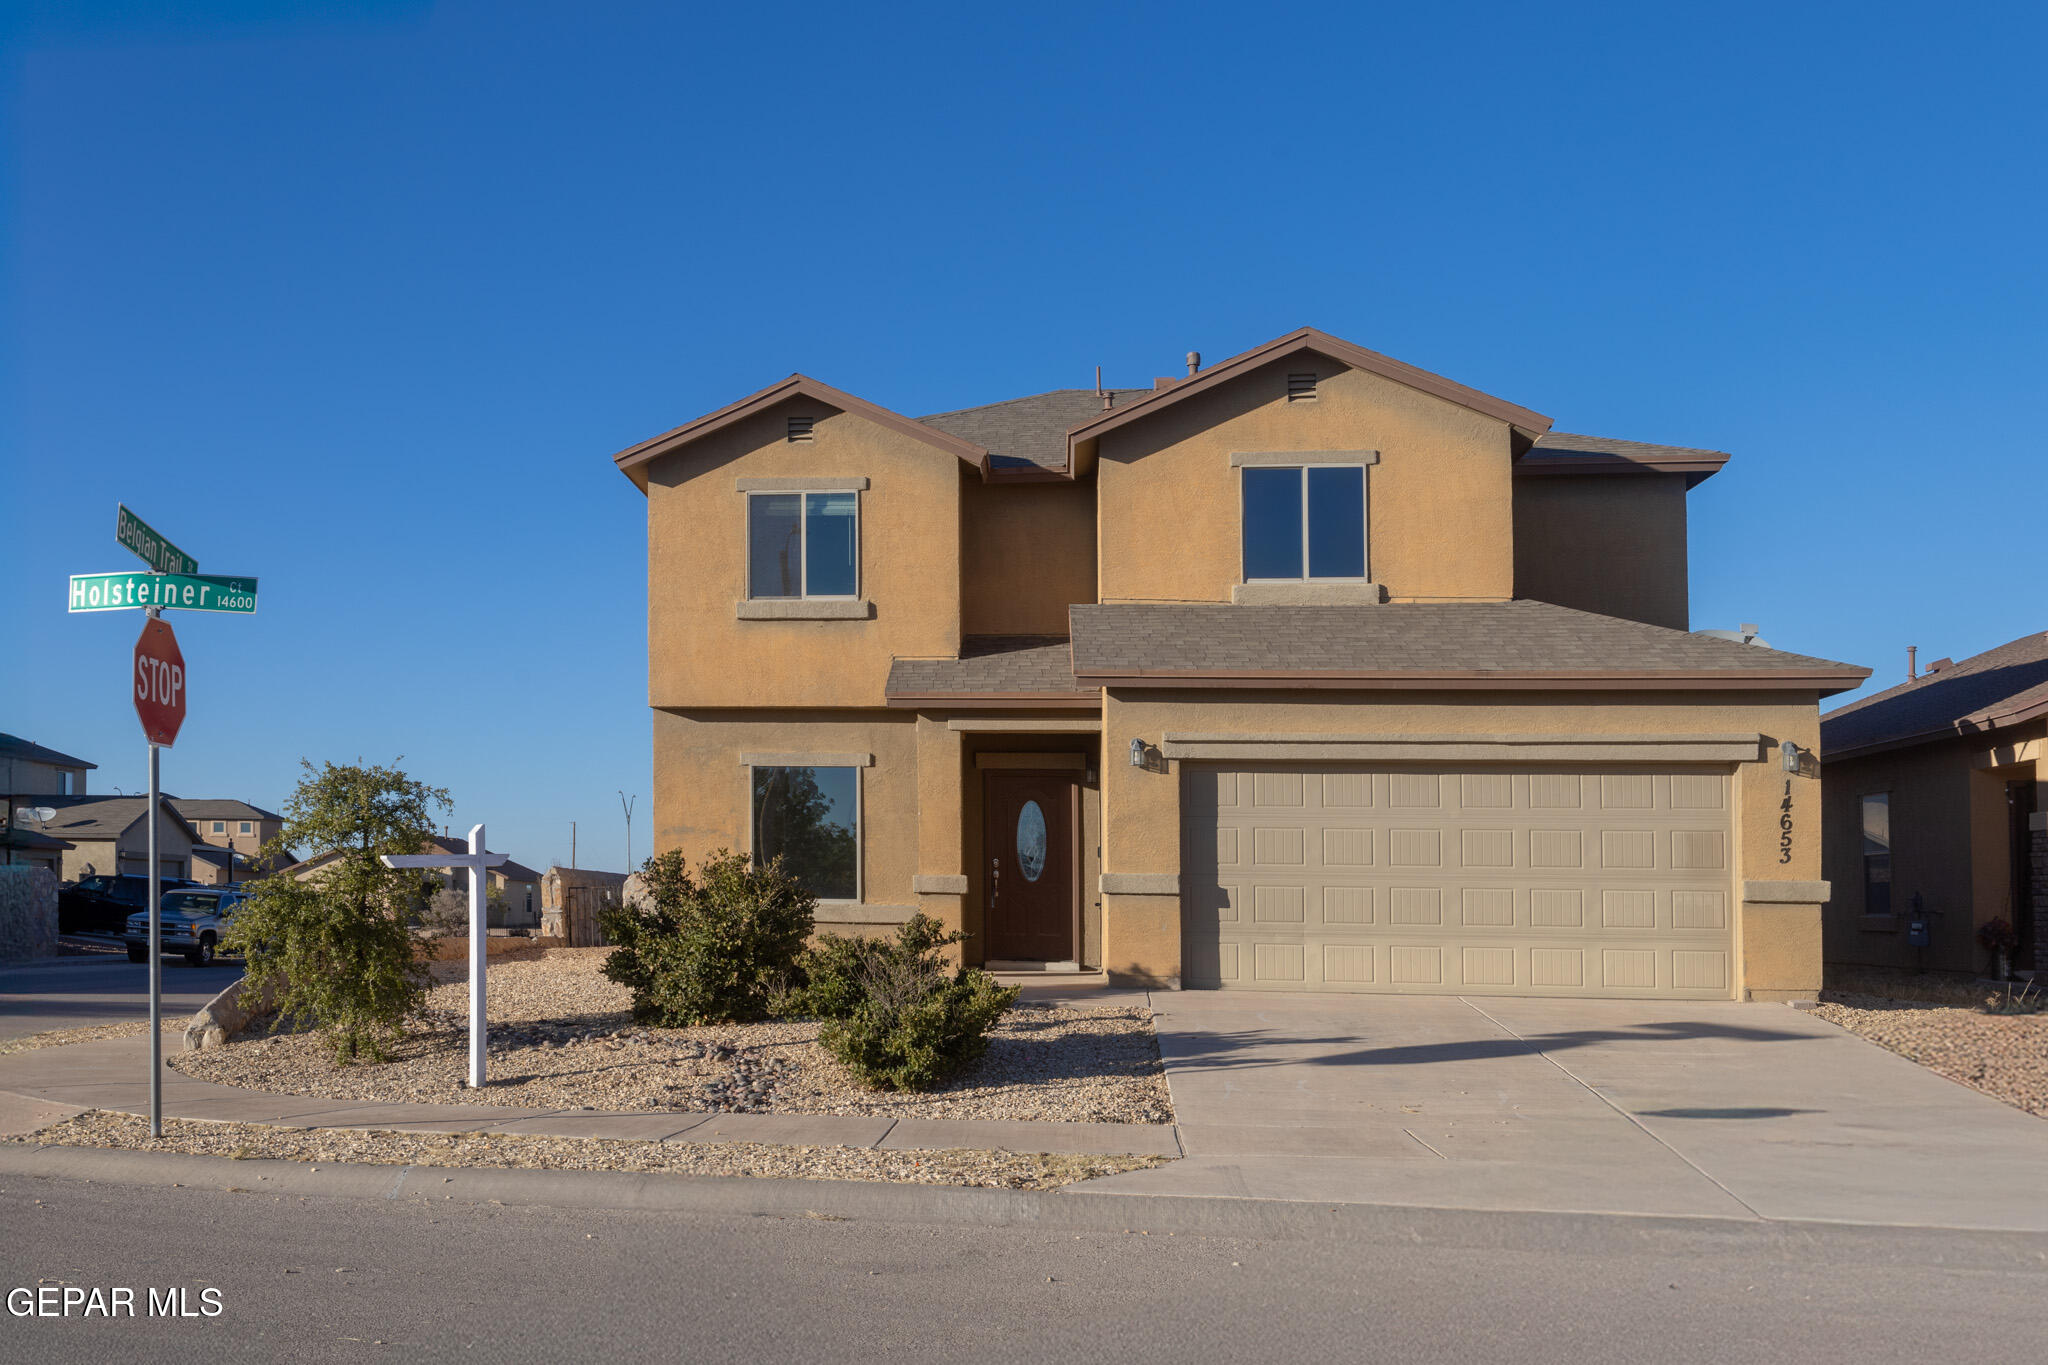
top-left (981, 767), bottom-right (1081, 962)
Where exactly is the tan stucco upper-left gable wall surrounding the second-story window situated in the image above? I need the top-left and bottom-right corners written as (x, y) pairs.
top-left (647, 397), bottom-right (961, 706)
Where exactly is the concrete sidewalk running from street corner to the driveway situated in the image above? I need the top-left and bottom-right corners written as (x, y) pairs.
top-left (0, 1038), bottom-right (1180, 1156)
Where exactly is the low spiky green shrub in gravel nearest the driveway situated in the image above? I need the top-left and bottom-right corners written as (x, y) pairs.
top-left (798, 915), bottom-right (1018, 1091)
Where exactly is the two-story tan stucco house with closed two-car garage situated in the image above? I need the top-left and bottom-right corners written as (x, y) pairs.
top-left (614, 329), bottom-right (1868, 999)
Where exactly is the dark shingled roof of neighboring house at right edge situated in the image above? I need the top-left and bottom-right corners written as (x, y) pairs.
top-left (1821, 630), bottom-right (2048, 759)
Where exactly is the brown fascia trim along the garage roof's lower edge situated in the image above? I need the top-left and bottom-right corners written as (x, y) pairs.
top-left (1075, 669), bottom-right (1870, 696)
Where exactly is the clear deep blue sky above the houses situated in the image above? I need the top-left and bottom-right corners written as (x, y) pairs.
top-left (0, 0), bottom-right (2048, 866)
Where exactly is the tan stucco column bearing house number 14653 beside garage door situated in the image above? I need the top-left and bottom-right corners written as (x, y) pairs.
top-left (1735, 724), bottom-right (1829, 1001)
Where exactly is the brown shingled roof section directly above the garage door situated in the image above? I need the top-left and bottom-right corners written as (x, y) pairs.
top-left (1069, 602), bottom-right (1870, 696)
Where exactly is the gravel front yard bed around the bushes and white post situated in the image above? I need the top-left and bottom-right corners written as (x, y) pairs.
top-left (172, 948), bottom-right (1174, 1124)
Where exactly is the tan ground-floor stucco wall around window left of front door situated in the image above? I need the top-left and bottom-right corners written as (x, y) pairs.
top-left (653, 710), bottom-right (920, 933)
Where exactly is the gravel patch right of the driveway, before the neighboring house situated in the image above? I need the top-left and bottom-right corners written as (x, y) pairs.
top-left (1812, 980), bottom-right (2048, 1117)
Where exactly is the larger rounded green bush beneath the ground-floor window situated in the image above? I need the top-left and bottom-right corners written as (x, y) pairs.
top-left (600, 849), bottom-right (817, 1027)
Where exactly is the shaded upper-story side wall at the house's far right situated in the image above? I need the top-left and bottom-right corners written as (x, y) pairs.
top-left (1513, 475), bottom-right (1687, 630)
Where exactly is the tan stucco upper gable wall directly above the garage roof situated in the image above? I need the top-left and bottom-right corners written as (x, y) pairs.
top-left (1096, 358), bottom-right (1513, 602)
